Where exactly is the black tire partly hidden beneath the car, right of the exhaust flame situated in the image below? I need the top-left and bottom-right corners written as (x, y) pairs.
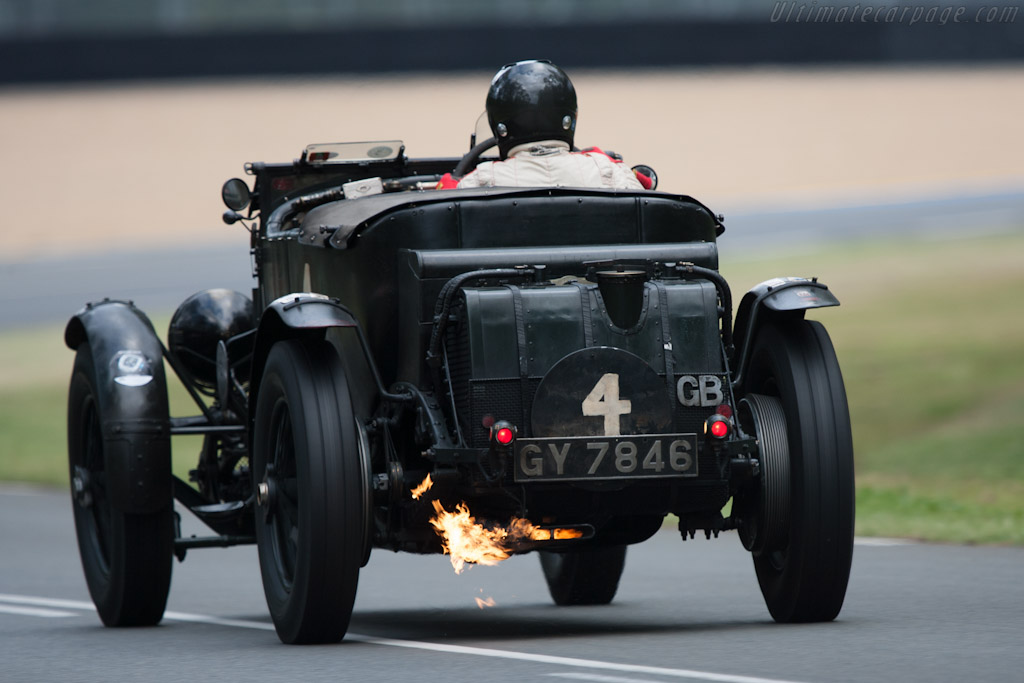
top-left (540, 546), bottom-right (626, 606)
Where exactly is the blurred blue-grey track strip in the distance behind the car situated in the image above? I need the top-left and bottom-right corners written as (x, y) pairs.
top-left (0, 193), bottom-right (1024, 330)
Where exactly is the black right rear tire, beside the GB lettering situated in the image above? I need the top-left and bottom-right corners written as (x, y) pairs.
top-left (743, 319), bottom-right (854, 623)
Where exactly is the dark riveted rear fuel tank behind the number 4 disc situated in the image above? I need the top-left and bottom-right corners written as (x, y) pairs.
top-left (446, 281), bottom-right (724, 445)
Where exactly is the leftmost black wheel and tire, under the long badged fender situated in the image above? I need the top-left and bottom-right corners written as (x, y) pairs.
top-left (68, 342), bottom-right (174, 627)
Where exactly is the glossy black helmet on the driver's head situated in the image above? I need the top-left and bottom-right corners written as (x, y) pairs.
top-left (487, 59), bottom-right (577, 159)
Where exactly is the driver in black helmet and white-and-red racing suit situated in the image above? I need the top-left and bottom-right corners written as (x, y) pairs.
top-left (437, 59), bottom-right (651, 189)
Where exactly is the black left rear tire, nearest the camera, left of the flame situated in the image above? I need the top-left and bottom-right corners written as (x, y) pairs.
top-left (253, 340), bottom-right (366, 643)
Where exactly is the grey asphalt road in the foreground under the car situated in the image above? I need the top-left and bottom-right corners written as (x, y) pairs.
top-left (0, 488), bottom-right (1024, 683)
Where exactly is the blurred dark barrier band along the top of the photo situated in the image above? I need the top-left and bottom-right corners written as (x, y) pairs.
top-left (0, 0), bottom-right (1024, 83)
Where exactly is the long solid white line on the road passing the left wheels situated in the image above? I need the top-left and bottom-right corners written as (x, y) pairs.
top-left (0, 593), bottom-right (815, 683)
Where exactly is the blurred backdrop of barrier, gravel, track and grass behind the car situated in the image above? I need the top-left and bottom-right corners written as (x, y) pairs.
top-left (0, 0), bottom-right (1024, 544)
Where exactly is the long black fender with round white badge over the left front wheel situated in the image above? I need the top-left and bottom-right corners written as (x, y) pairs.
top-left (65, 299), bottom-right (173, 514)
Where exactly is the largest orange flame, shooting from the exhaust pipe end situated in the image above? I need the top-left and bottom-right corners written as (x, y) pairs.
top-left (430, 501), bottom-right (583, 573)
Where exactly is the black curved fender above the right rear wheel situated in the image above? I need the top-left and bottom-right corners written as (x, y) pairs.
top-left (732, 278), bottom-right (840, 388)
